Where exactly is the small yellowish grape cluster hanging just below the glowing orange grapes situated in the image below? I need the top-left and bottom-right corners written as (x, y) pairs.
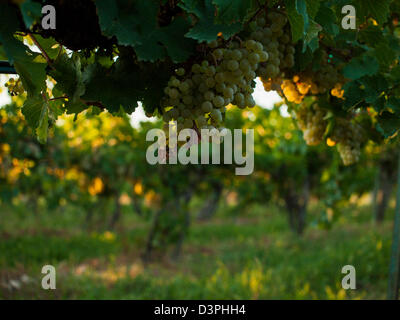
top-left (296, 104), bottom-right (328, 146)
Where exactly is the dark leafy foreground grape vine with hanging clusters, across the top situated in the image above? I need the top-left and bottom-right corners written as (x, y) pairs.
top-left (0, 0), bottom-right (400, 168)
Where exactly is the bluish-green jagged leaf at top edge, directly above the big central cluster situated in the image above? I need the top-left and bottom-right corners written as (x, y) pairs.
top-left (179, 0), bottom-right (243, 42)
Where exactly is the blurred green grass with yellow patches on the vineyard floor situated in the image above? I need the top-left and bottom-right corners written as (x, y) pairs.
top-left (0, 200), bottom-right (392, 299)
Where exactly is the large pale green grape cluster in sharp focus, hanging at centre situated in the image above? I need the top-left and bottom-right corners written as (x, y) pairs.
top-left (162, 39), bottom-right (269, 131)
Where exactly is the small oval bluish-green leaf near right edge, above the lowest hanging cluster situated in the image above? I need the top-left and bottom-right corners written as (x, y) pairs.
top-left (343, 54), bottom-right (379, 80)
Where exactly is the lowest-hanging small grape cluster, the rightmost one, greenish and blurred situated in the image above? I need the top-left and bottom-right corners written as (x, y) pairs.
top-left (330, 119), bottom-right (365, 166)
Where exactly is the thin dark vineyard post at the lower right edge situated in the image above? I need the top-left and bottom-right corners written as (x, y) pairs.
top-left (387, 152), bottom-right (400, 300)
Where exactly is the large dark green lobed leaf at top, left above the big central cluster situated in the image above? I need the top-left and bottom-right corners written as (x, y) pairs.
top-left (96, 0), bottom-right (195, 63)
